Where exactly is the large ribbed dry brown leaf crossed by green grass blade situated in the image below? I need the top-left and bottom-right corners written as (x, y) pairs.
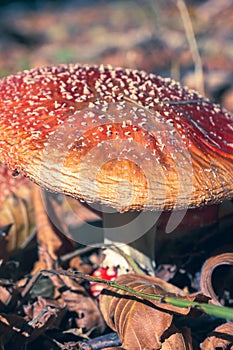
top-left (100, 274), bottom-right (191, 350)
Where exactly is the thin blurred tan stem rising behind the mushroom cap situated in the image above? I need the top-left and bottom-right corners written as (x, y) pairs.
top-left (177, 0), bottom-right (205, 94)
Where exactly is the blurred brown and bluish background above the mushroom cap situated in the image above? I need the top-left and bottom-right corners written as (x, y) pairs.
top-left (0, 0), bottom-right (233, 110)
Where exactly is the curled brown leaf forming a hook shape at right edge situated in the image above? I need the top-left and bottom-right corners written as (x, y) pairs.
top-left (200, 253), bottom-right (233, 305)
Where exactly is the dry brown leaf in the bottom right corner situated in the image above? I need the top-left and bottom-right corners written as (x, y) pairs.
top-left (200, 323), bottom-right (233, 350)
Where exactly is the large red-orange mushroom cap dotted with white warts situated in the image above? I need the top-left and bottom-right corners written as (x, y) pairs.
top-left (0, 65), bottom-right (233, 211)
